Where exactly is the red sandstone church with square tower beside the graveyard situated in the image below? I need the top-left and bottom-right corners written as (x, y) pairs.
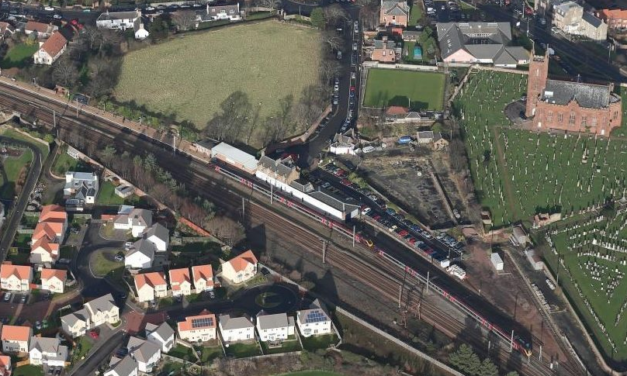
top-left (525, 49), bottom-right (622, 136)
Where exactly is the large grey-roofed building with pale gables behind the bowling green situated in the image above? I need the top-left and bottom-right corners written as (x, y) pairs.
top-left (436, 22), bottom-right (529, 68)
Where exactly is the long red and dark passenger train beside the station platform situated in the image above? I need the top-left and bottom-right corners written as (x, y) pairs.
top-left (208, 157), bottom-right (533, 357)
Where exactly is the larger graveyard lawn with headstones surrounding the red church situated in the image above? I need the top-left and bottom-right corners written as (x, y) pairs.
top-left (455, 72), bottom-right (627, 226)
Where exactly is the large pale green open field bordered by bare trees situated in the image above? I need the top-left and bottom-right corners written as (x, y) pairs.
top-left (115, 21), bottom-right (322, 147)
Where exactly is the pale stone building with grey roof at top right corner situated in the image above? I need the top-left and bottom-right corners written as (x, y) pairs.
top-left (553, 1), bottom-right (608, 41)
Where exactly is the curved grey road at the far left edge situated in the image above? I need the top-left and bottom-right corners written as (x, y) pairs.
top-left (0, 136), bottom-right (43, 261)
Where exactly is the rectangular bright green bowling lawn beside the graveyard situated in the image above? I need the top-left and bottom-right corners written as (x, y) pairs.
top-left (364, 69), bottom-right (446, 110)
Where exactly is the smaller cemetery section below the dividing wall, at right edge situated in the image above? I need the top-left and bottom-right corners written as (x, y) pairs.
top-left (544, 213), bottom-right (627, 361)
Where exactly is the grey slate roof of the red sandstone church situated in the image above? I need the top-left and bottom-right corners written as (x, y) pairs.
top-left (542, 80), bottom-right (611, 108)
